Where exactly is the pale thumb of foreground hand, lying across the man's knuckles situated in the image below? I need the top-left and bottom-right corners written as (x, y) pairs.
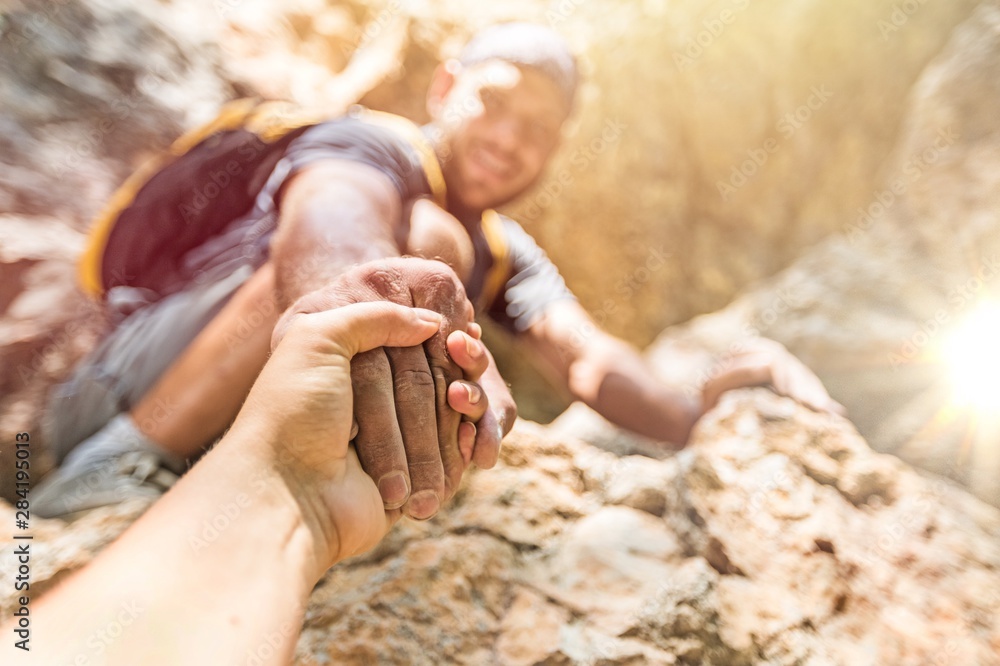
top-left (279, 301), bottom-right (442, 360)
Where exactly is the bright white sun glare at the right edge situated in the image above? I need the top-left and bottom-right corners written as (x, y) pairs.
top-left (944, 302), bottom-right (1000, 415)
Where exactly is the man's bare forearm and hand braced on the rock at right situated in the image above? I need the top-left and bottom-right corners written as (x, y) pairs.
top-left (525, 300), bottom-right (843, 448)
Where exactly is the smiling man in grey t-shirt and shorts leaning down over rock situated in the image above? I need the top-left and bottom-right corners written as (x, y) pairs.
top-left (32, 24), bottom-right (841, 519)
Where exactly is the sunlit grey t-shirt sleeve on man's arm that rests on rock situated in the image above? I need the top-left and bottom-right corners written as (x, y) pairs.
top-left (487, 217), bottom-right (576, 334)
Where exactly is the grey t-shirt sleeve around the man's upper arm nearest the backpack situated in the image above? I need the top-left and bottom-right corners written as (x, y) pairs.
top-left (263, 116), bottom-right (430, 203)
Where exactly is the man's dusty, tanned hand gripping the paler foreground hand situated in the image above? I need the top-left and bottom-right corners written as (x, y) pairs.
top-left (272, 258), bottom-right (516, 519)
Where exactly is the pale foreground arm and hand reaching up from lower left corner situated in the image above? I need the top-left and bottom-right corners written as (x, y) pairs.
top-left (11, 303), bottom-right (441, 666)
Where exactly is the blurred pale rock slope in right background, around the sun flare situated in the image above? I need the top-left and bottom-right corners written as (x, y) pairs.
top-left (560, 2), bottom-right (1000, 505)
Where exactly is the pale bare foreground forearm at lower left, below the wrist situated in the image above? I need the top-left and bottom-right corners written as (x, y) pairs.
top-left (27, 438), bottom-right (315, 666)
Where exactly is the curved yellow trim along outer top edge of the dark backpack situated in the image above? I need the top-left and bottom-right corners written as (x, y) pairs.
top-left (77, 98), bottom-right (328, 298)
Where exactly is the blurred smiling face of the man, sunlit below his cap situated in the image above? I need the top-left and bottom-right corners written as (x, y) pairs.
top-left (428, 60), bottom-right (570, 215)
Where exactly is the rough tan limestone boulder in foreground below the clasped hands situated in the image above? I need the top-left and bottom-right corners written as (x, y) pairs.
top-left (0, 389), bottom-right (1000, 666)
